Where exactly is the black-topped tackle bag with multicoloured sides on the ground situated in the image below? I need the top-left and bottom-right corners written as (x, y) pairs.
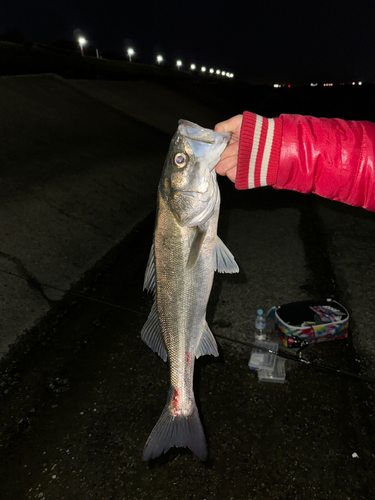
top-left (267, 299), bottom-right (349, 347)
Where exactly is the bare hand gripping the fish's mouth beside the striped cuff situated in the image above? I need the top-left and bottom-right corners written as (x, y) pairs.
top-left (214, 115), bottom-right (242, 182)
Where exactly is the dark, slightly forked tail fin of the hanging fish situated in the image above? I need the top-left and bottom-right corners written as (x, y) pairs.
top-left (142, 396), bottom-right (207, 461)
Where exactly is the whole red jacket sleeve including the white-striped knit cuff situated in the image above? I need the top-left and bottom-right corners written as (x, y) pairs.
top-left (236, 112), bottom-right (375, 211)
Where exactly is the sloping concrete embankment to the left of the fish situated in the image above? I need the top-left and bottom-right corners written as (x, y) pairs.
top-left (0, 75), bottom-right (223, 355)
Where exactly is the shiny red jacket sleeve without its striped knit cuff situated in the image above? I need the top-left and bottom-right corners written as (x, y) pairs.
top-left (274, 115), bottom-right (375, 211)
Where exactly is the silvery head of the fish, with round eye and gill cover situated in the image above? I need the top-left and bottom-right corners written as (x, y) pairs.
top-left (159, 120), bottom-right (231, 227)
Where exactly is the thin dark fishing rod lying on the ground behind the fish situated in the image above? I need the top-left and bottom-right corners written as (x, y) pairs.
top-left (0, 269), bottom-right (375, 384)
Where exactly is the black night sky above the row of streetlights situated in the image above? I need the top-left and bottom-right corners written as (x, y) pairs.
top-left (0, 0), bottom-right (375, 83)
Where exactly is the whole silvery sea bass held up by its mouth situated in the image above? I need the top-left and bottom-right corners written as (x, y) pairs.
top-left (142, 120), bottom-right (238, 460)
